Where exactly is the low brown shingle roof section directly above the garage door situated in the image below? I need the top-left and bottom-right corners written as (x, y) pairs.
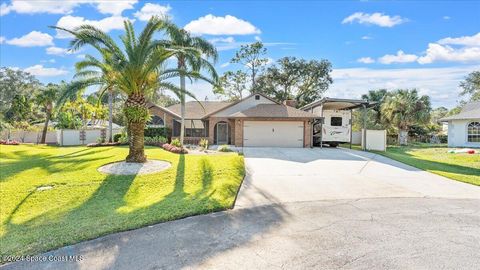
top-left (230, 104), bottom-right (318, 118)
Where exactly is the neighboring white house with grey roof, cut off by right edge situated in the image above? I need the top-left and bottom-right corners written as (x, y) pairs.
top-left (440, 101), bottom-right (480, 147)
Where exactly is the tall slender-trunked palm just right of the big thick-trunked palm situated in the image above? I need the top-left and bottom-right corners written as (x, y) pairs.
top-left (165, 23), bottom-right (218, 145)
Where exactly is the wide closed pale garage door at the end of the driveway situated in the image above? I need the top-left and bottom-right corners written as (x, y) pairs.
top-left (243, 121), bottom-right (303, 147)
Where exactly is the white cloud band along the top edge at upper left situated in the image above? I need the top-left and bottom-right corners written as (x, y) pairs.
top-left (0, 0), bottom-right (138, 16)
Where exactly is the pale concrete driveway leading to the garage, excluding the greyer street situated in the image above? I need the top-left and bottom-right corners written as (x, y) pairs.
top-left (235, 148), bottom-right (480, 207)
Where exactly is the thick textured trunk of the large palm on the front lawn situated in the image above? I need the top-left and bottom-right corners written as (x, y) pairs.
top-left (125, 94), bottom-right (148, 163)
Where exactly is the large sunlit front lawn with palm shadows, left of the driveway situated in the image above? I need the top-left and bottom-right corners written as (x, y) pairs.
top-left (0, 145), bottom-right (245, 258)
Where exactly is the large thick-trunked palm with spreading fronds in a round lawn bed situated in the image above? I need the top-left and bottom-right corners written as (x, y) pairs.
top-left (58, 17), bottom-right (200, 162)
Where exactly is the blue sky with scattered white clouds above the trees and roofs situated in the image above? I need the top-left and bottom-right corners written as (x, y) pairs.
top-left (0, 0), bottom-right (480, 108)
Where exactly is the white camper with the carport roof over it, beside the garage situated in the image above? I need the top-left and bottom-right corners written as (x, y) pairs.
top-left (301, 98), bottom-right (373, 147)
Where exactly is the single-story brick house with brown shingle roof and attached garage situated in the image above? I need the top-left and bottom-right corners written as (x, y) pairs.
top-left (149, 93), bottom-right (318, 147)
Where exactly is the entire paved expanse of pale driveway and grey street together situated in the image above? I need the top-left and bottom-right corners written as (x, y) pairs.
top-left (4, 148), bottom-right (480, 269)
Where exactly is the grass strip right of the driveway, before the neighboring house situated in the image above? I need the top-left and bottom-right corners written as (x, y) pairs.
top-left (352, 144), bottom-right (480, 186)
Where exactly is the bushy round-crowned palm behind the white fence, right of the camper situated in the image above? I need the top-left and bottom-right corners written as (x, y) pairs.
top-left (381, 89), bottom-right (432, 145)
